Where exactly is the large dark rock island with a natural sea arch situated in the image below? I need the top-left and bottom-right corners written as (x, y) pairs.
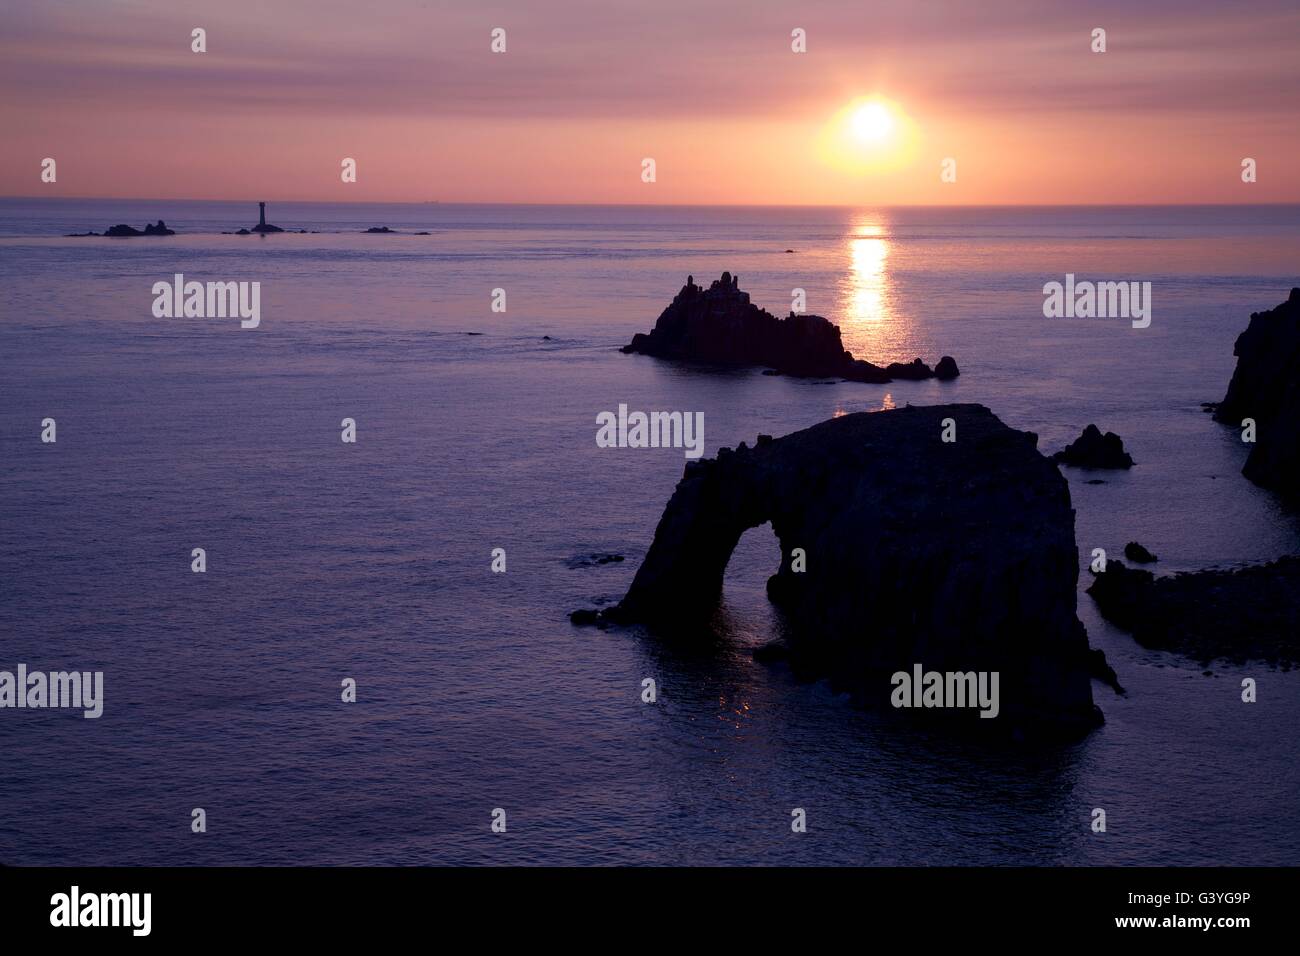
top-left (572, 405), bottom-right (1101, 736)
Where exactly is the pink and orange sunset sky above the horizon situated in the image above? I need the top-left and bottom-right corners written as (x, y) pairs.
top-left (0, 0), bottom-right (1300, 206)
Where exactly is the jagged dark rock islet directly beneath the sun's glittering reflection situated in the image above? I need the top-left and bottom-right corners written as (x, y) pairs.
top-left (620, 272), bottom-right (958, 384)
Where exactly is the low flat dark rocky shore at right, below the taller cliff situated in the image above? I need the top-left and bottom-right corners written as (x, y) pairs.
top-left (1088, 557), bottom-right (1300, 666)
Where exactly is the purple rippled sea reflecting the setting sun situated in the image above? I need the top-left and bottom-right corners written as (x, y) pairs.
top-left (0, 199), bottom-right (1300, 865)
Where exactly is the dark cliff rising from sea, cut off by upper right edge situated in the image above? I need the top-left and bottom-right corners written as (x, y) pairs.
top-left (1214, 289), bottom-right (1300, 498)
